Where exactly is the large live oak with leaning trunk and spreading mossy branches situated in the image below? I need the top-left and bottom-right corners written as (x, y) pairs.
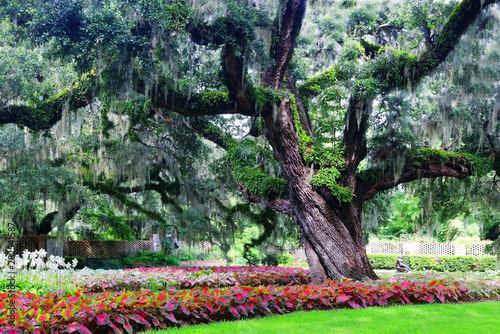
top-left (0, 0), bottom-right (498, 282)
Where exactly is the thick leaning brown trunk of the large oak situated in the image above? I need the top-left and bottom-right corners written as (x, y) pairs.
top-left (264, 96), bottom-right (377, 283)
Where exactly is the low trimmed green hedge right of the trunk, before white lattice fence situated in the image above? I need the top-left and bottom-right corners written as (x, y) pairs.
top-left (368, 254), bottom-right (496, 272)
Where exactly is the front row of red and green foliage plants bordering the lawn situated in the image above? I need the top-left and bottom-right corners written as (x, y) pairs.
top-left (0, 280), bottom-right (472, 334)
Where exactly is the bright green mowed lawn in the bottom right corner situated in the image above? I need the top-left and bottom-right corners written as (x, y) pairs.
top-left (144, 302), bottom-right (500, 334)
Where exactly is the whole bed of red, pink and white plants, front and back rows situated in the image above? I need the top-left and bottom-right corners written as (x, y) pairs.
top-left (0, 267), bottom-right (500, 333)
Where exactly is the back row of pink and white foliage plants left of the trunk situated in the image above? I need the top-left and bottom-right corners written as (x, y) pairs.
top-left (75, 267), bottom-right (310, 292)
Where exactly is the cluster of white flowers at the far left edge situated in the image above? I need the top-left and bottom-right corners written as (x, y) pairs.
top-left (0, 249), bottom-right (78, 270)
